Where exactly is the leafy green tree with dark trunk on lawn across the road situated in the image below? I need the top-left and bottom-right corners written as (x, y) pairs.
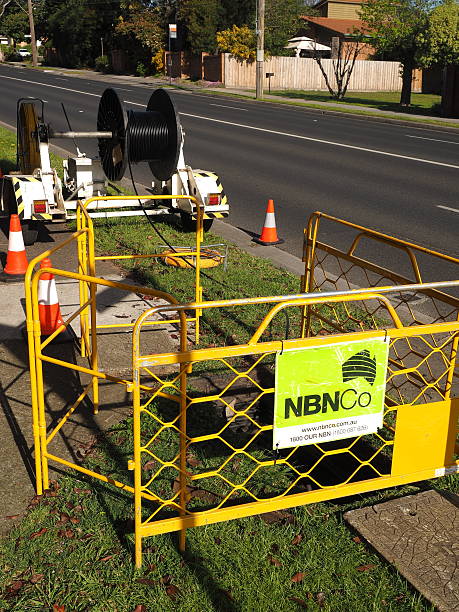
top-left (360, 0), bottom-right (433, 106)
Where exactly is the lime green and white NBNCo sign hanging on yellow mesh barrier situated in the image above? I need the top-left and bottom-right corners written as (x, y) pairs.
top-left (273, 337), bottom-right (389, 448)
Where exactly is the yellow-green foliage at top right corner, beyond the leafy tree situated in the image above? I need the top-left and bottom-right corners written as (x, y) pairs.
top-left (424, 0), bottom-right (459, 66)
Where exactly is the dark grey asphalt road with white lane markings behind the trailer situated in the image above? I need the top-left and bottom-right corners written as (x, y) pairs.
top-left (0, 66), bottom-right (459, 280)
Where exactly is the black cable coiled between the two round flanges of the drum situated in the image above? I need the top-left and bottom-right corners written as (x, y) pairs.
top-left (127, 111), bottom-right (169, 163)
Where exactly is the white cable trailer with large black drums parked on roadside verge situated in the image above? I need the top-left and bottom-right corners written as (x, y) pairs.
top-left (0, 88), bottom-right (229, 244)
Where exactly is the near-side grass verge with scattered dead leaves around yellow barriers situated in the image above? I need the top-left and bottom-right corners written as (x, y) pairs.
top-left (0, 126), bottom-right (458, 612)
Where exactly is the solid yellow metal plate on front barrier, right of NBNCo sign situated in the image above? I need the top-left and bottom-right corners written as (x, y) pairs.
top-left (392, 399), bottom-right (459, 476)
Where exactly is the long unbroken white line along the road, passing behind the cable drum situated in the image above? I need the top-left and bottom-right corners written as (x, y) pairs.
top-left (0, 75), bottom-right (459, 170)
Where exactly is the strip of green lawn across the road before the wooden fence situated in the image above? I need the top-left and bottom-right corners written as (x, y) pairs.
top-left (272, 89), bottom-right (441, 117)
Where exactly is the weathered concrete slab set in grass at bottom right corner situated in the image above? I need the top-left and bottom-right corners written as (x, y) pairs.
top-left (344, 490), bottom-right (459, 612)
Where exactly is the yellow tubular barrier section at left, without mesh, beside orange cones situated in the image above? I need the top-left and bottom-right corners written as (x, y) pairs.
top-left (24, 196), bottom-right (203, 495)
